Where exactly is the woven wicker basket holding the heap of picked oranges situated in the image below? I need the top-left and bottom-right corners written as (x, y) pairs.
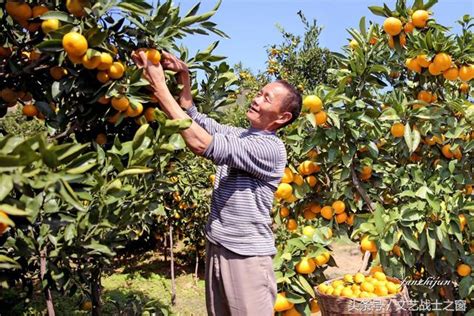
top-left (314, 277), bottom-right (411, 316)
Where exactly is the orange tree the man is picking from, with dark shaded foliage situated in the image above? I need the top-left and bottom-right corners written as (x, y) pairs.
top-left (0, 0), bottom-right (239, 314)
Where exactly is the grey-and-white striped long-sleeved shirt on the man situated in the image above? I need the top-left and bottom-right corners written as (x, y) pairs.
top-left (187, 106), bottom-right (287, 256)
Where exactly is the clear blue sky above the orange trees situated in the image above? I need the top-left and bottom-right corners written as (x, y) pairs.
top-left (175, 0), bottom-right (474, 71)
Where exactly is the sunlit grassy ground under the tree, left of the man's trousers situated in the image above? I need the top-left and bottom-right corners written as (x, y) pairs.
top-left (2, 252), bottom-right (206, 316)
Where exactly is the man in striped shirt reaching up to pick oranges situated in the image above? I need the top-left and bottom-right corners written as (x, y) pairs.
top-left (134, 52), bottom-right (301, 316)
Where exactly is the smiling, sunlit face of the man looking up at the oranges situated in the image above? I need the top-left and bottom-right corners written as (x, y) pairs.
top-left (247, 82), bottom-right (291, 131)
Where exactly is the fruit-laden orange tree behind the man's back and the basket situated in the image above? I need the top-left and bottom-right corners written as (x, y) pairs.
top-left (237, 1), bottom-right (474, 314)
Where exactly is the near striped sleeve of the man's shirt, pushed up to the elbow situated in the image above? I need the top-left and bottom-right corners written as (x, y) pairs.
top-left (203, 133), bottom-right (286, 180)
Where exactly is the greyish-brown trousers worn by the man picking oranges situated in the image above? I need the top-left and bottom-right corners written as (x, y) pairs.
top-left (206, 241), bottom-right (277, 316)
